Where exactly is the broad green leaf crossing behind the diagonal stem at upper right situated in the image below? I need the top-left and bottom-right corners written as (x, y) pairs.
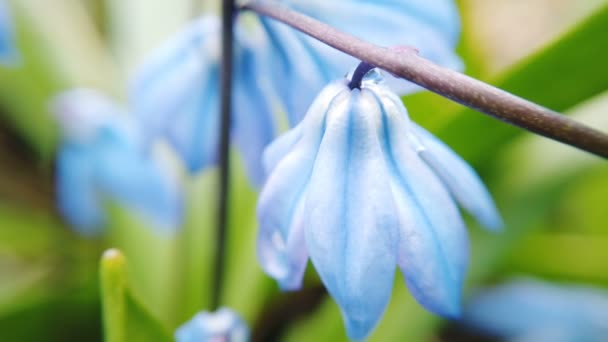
top-left (430, 5), bottom-right (608, 164)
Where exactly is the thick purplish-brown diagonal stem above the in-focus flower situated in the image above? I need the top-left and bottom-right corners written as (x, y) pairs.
top-left (243, 1), bottom-right (608, 158)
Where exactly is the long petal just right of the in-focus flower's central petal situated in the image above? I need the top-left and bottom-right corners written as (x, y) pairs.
top-left (368, 86), bottom-right (469, 317)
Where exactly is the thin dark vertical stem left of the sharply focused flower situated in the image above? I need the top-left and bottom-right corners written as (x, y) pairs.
top-left (211, 0), bottom-right (235, 311)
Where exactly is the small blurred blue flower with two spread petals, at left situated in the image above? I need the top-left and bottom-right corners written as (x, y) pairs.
top-left (53, 89), bottom-right (182, 235)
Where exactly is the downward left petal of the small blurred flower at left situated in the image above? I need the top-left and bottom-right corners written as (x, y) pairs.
top-left (56, 144), bottom-right (105, 236)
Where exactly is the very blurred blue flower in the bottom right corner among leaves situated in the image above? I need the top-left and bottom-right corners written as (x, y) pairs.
top-left (463, 279), bottom-right (608, 342)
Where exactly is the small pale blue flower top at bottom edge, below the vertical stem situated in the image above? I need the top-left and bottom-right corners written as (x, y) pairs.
top-left (175, 308), bottom-right (249, 342)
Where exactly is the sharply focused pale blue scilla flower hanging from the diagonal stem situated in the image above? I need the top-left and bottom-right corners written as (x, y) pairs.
top-left (258, 69), bottom-right (501, 339)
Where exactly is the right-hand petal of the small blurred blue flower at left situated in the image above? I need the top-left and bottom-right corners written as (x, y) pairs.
top-left (94, 129), bottom-right (182, 231)
